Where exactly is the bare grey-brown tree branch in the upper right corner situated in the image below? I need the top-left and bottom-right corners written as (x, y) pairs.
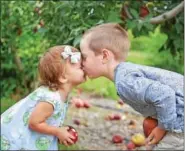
top-left (150, 1), bottom-right (184, 24)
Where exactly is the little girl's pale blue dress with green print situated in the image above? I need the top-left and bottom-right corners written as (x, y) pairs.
top-left (1, 86), bottom-right (68, 150)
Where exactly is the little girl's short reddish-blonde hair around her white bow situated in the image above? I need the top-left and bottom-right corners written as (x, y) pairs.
top-left (38, 45), bottom-right (78, 90)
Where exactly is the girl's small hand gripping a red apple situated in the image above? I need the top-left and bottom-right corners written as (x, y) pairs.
top-left (57, 127), bottom-right (75, 146)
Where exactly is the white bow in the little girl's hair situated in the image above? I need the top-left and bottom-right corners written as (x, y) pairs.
top-left (61, 46), bottom-right (81, 63)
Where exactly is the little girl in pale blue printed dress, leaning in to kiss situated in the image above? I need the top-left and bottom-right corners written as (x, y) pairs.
top-left (1, 46), bottom-right (85, 150)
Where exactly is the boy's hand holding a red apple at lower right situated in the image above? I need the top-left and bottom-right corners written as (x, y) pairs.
top-left (146, 127), bottom-right (166, 145)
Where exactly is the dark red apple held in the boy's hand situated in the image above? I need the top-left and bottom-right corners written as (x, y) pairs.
top-left (143, 117), bottom-right (158, 137)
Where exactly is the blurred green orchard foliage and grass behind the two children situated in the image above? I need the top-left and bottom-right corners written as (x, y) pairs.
top-left (1, 0), bottom-right (184, 102)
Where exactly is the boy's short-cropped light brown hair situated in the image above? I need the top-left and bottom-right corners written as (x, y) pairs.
top-left (83, 23), bottom-right (130, 60)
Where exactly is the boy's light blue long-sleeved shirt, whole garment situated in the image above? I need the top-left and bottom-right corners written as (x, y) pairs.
top-left (114, 62), bottom-right (184, 133)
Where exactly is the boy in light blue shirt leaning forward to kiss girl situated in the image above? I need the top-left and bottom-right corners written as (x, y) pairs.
top-left (80, 23), bottom-right (184, 150)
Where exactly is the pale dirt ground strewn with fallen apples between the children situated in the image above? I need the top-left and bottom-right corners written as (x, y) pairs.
top-left (64, 94), bottom-right (148, 150)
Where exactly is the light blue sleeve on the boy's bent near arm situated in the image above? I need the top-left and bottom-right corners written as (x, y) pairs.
top-left (117, 71), bottom-right (177, 131)
